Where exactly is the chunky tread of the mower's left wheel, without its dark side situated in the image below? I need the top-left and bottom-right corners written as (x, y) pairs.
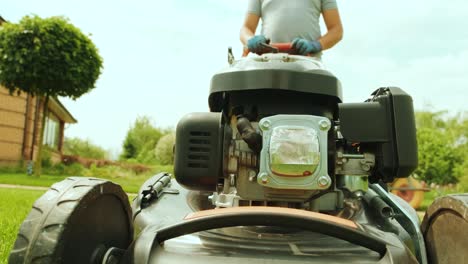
top-left (8, 177), bottom-right (120, 264)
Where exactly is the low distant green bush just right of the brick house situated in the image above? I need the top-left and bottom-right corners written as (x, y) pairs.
top-left (63, 137), bottom-right (109, 159)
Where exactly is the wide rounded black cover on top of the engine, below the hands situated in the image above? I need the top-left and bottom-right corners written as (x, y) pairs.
top-left (208, 67), bottom-right (342, 114)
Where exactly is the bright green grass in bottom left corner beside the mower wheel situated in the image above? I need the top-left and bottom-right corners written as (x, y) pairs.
top-left (0, 188), bottom-right (44, 263)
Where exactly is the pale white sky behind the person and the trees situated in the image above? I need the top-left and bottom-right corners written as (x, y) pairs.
top-left (0, 0), bottom-right (468, 153)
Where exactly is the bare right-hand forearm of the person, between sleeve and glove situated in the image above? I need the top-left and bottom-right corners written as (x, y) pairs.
top-left (318, 8), bottom-right (343, 50)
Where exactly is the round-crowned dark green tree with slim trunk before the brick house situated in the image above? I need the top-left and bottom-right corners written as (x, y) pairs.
top-left (0, 16), bottom-right (102, 176)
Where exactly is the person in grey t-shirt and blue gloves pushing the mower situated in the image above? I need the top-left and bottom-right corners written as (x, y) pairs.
top-left (240, 0), bottom-right (343, 59)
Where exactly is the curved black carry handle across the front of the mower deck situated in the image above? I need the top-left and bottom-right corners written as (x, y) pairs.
top-left (153, 207), bottom-right (387, 257)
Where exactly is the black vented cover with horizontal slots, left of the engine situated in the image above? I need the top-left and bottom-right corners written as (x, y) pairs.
top-left (174, 113), bottom-right (223, 191)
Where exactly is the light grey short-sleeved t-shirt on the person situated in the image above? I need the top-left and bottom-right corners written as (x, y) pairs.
top-left (248, 0), bottom-right (337, 43)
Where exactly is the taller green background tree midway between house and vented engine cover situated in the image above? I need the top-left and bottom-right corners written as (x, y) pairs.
top-left (120, 116), bottom-right (163, 163)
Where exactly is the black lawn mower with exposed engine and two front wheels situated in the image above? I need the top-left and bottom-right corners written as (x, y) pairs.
top-left (9, 44), bottom-right (468, 264)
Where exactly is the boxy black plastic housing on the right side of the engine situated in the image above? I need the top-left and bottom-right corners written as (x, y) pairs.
top-left (338, 87), bottom-right (418, 182)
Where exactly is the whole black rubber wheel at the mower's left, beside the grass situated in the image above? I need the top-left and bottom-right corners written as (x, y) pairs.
top-left (8, 177), bottom-right (133, 264)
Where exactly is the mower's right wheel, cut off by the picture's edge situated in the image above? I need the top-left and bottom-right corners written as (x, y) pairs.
top-left (421, 194), bottom-right (468, 263)
